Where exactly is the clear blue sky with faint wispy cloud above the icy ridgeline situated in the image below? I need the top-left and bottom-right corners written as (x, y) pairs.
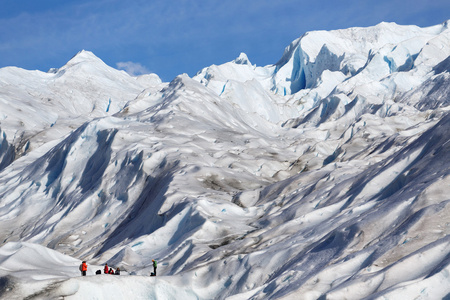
top-left (0, 0), bottom-right (450, 81)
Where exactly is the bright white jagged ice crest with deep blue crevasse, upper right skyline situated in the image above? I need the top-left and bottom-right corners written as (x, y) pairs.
top-left (273, 23), bottom-right (448, 94)
